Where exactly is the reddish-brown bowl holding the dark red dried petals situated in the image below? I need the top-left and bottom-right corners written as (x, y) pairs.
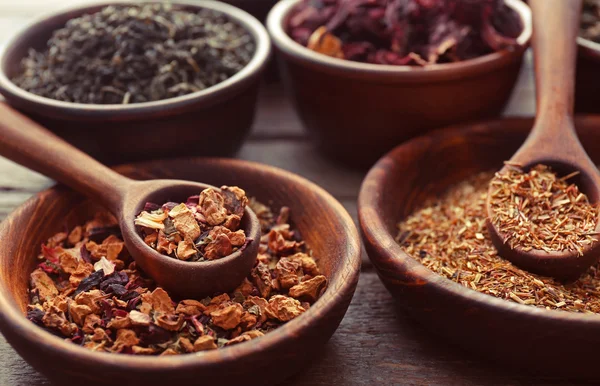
top-left (267, 0), bottom-right (531, 166)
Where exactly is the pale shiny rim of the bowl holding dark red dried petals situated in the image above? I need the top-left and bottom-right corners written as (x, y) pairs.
top-left (267, 0), bottom-right (532, 80)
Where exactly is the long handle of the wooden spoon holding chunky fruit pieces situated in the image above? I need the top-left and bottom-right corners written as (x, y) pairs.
top-left (0, 103), bottom-right (132, 212)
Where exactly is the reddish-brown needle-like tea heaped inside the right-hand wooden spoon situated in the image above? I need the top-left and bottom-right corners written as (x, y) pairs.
top-left (490, 165), bottom-right (598, 255)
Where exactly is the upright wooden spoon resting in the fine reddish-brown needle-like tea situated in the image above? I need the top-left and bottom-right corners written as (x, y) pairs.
top-left (487, 0), bottom-right (600, 280)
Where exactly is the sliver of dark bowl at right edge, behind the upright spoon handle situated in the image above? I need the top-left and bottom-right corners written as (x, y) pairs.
top-left (575, 38), bottom-right (600, 114)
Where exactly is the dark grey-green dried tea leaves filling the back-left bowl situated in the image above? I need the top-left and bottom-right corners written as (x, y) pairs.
top-left (12, 4), bottom-right (255, 104)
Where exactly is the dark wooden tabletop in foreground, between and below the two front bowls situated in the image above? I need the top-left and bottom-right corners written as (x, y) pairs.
top-left (0, 272), bottom-right (584, 386)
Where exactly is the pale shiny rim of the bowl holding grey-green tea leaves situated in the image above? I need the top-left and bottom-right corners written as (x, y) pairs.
top-left (0, 0), bottom-right (271, 118)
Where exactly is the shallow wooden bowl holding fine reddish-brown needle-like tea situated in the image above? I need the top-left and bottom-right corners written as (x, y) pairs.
top-left (358, 117), bottom-right (600, 377)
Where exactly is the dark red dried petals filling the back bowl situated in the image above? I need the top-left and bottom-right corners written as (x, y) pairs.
top-left (287, 0), bottom-right (523, 66)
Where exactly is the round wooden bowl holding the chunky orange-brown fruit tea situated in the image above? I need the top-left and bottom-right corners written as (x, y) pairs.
top-left (0, 158), bottom-right (360, 386)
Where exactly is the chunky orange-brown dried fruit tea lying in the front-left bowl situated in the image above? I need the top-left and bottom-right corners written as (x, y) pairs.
top-left (27, 201), bottom-right (327, 355)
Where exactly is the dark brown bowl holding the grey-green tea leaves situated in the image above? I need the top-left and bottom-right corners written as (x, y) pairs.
top-left (0, 0), bottom-right (271, 164)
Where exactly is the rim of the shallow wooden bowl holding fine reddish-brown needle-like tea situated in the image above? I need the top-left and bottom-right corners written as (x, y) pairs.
top-left (358, 116), bottom-right (600, 326)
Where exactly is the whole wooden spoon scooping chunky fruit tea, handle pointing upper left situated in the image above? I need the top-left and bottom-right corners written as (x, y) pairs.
top-left (0, 104), bottom-right (261, 297)
